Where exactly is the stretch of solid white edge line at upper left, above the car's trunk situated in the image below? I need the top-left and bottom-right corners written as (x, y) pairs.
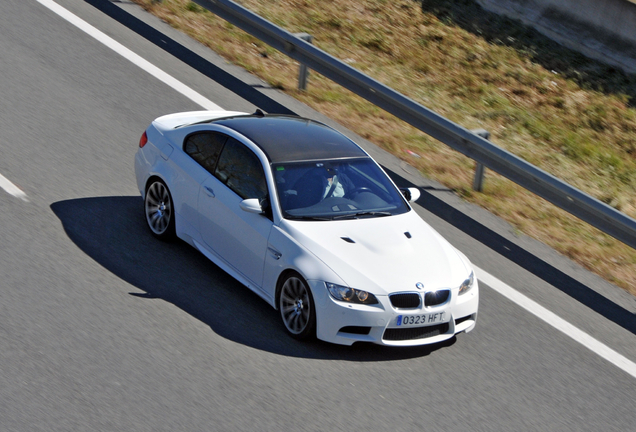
top-left (37, 0), bottom-right (222, 110)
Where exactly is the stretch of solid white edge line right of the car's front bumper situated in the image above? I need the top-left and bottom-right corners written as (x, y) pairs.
top-left (473, 265), bottom-right (636, 378)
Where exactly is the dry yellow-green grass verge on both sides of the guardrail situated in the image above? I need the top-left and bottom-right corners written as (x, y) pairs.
top-left (134, 0), bottom-right (636, 294)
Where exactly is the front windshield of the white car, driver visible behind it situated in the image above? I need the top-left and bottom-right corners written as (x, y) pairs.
top-left (272, 158), bottom-right (408, 220)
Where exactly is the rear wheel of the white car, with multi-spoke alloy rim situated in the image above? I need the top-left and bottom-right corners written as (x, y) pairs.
top-left (144, 179), bottom-right (176, 241)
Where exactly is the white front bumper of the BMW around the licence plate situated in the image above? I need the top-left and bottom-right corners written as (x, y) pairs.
top-left (308, 280), bottom-right (479, 346)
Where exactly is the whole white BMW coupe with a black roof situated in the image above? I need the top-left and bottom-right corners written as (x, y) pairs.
top-left (135, 110), bottom-right (479, 346)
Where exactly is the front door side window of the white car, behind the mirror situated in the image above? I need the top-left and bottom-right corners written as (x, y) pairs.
top-left (214, 138), bottom-right (267, 199)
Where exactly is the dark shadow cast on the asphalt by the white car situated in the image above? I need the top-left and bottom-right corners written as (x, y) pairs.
top-left (51, 196), bottom-right (456, 362)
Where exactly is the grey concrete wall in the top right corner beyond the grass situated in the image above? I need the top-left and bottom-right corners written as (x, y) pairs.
top-left (476, 0), bottom-right (636, 73)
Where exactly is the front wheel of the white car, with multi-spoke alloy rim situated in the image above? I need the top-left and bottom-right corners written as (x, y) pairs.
top-left (278, 273), bottom-right (316, 340)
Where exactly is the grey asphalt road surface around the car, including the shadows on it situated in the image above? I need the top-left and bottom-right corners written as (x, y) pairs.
top-left (0, 0), bottom-right (636, 431)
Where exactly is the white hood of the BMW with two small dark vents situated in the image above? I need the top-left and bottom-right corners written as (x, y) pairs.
top-left (281, 211), bottom-right (470, 295)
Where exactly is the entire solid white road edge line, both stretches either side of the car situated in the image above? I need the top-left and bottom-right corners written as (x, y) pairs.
top-left (37, 0), bottom-right (636, 378)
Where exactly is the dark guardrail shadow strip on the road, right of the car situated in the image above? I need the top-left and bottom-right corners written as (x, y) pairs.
top-left (383, 167), bottom-right (636, 334)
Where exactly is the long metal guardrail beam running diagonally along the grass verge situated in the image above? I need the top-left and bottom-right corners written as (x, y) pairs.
top-left (194, 0), bottom-right (636, 249)
